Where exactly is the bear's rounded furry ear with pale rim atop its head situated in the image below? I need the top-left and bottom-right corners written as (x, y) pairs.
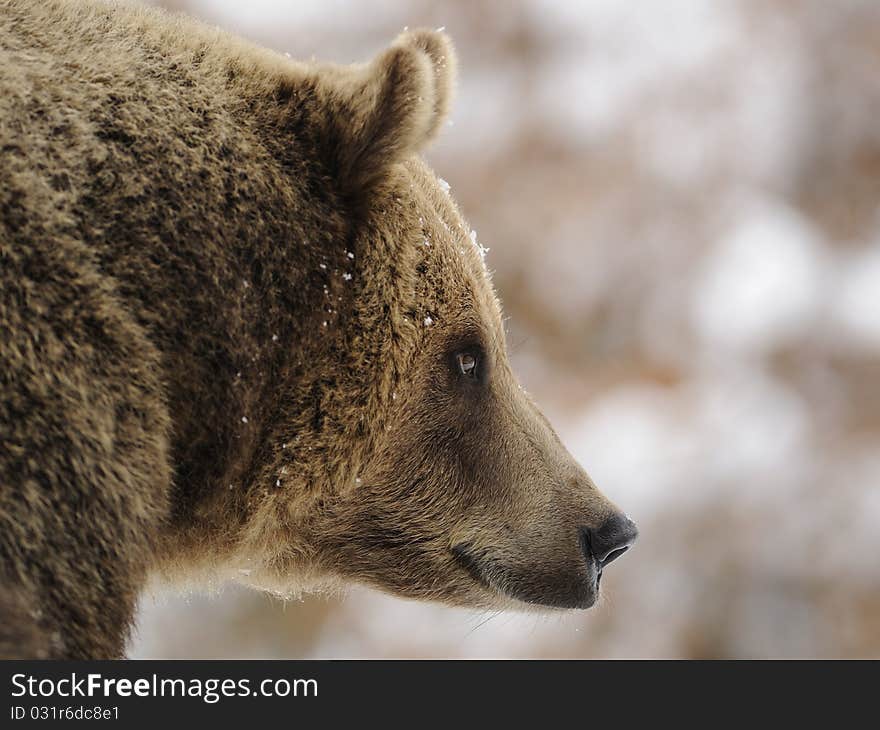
top-left (327, 30), bottom-right (455, 192)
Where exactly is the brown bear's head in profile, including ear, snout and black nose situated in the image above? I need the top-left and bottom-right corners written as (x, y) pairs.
top-left (230, 31), bottom-right (636, 608)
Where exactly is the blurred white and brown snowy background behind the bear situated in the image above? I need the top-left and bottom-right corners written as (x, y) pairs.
top-left (132, 0), bottom-right (880, 657)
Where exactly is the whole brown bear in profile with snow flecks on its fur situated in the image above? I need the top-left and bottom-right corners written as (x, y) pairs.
top-left (0, 0), bottom-right (636, 658)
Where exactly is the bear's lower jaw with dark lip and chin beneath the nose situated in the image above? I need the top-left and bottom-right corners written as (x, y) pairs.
top-left (450, 544), bottom-right (602, 609)
